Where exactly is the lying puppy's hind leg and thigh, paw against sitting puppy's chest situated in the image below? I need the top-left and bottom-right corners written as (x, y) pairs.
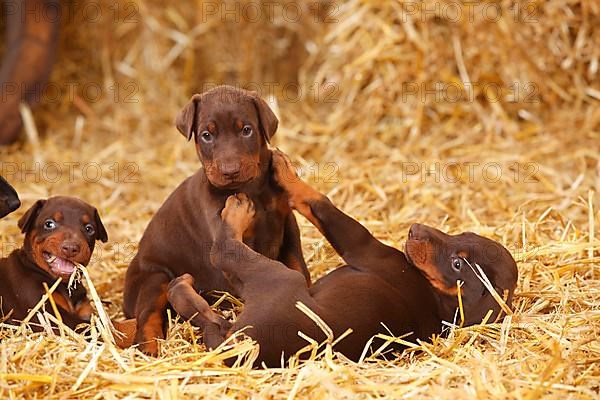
top-left (216, 195), bottom-right (325, 366)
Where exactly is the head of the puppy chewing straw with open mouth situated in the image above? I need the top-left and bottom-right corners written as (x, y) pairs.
top-left (19, 196), bottom-right (108, 281)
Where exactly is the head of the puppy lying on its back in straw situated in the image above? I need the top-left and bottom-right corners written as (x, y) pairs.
top-left (406, 224), bottom-right (518, 325)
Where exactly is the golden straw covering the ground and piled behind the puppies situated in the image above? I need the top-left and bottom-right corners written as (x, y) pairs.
top-left (0, 0), bottom-right (600, 398)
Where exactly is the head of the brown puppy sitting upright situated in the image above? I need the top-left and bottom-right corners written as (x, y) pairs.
top-left (175, 86), bottom-right (278, 190)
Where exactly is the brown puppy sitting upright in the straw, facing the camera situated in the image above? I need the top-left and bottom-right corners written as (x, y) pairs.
top-left (124, 86), bottom-right (310, 355)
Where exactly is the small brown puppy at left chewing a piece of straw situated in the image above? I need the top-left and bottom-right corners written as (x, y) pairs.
top-left (0, 196), bottom-right (108, 329)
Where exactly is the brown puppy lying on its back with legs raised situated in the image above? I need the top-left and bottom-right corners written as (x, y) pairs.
top-left (169, 154), bottom-right (517, 366)
